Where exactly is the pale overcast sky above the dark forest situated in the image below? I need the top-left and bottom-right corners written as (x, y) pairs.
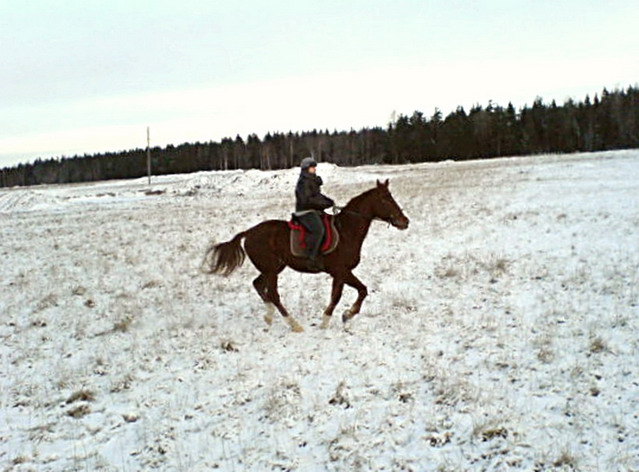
top-left (0, 0), bottom-right (639, 167)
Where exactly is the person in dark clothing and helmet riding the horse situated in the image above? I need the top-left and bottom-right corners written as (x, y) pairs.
top-left (295, 157), bottom-right (335, 270)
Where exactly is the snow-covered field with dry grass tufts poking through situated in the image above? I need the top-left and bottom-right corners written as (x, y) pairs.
top-left (0, 151), bottom-right (639, 471)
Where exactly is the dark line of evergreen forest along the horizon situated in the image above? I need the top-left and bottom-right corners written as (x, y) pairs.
top-left (0, 87), bottom-right (639, 187)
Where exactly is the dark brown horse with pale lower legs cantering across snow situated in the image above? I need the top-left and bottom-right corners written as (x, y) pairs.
top-left (203, 179), bottom-right (409, 332)
